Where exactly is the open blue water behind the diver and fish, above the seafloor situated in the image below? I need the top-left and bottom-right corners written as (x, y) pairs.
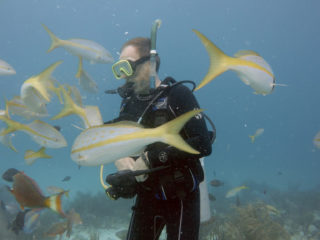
top-left (0, 0), bottom-right (320, 199)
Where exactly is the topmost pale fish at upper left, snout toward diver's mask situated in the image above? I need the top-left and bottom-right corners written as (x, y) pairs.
top-left (42, 24), bottom-right (114, 63)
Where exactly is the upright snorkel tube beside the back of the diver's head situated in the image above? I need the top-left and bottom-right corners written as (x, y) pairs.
top-left (150, 19), bottom-right (161, 89)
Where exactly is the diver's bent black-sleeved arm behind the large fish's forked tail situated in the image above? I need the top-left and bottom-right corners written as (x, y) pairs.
top-left (147, 85), bottom-right (215, 166)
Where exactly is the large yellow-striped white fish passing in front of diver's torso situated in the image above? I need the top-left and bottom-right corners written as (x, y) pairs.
top-left (71, 109), bottom-right (202, 166)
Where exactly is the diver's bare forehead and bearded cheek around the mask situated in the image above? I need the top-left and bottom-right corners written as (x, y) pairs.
top-left (119, 45), bottom-right (150, 94)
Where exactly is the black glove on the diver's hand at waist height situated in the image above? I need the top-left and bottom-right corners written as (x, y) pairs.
top-left (106, 170), bottom-right (138, 200)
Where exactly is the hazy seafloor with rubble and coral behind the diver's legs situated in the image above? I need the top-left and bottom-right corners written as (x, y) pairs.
top-left (3, 186), bottom-right (320, 240)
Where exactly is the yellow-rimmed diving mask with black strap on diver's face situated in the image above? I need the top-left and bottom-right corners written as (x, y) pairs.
top-left (112, 56), bottom-right (150, 79)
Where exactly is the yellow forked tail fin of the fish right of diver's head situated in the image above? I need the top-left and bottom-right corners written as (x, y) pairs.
top-left (192, 29), bottom-right (233, 90)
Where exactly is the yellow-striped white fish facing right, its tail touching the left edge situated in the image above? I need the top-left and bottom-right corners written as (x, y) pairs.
top-left (0, 114), bottom-right (67, 148)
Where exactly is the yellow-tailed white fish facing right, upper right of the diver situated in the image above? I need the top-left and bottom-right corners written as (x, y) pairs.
top-left (193, 30), bottom-right (276, 95)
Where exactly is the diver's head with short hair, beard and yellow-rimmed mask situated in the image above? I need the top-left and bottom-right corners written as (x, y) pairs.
top-left (112, 37), bottom-right (160, 94)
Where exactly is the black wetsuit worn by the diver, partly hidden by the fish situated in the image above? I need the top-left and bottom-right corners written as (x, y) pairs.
top-left (114, 78), bottom-right (212, 240)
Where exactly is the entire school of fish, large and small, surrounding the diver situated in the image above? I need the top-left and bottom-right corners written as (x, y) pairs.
top-left (0, 24), bottom-right (320, 236)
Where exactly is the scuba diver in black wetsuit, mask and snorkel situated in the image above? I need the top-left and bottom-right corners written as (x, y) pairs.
top-left (106, 21), bottom-right (215, 240)
